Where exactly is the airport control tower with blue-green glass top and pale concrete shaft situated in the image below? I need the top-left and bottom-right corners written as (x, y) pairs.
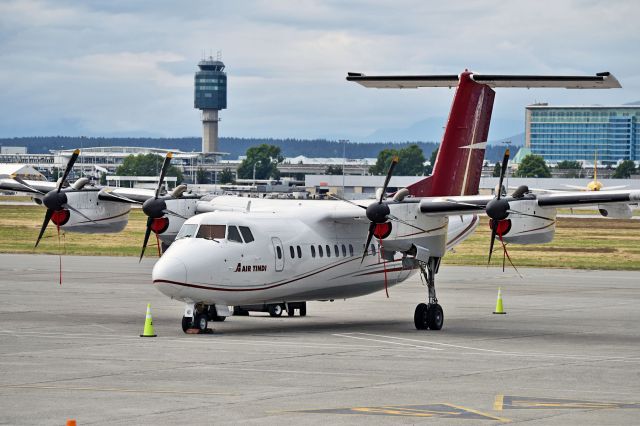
top-left (193, 56), bottom-right (227, 152)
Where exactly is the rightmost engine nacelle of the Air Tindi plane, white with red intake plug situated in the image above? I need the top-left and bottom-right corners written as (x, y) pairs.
top-left (501, 200), bottom-right (556, 244)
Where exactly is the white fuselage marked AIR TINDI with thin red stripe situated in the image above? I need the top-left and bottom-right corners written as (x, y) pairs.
top-left (153, 197), bottom-right (478, 305)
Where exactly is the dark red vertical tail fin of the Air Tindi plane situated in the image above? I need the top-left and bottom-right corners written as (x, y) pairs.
top-left (407, 71), bottom-right (495, 197)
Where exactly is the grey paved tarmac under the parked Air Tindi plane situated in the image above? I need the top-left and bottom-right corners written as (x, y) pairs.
top-left (0, 255), bottom-right (640, 425)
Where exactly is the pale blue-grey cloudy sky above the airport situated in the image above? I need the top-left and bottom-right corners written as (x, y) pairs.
top-left (0, 0), bottom-right (640, 140)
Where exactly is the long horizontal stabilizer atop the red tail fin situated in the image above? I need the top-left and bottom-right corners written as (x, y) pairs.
top-left (347, 72), bottom-right (622, 89)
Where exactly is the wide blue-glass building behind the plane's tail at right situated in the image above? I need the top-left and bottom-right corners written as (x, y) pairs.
top-left (525, 104), bottom-right (640, 163)
